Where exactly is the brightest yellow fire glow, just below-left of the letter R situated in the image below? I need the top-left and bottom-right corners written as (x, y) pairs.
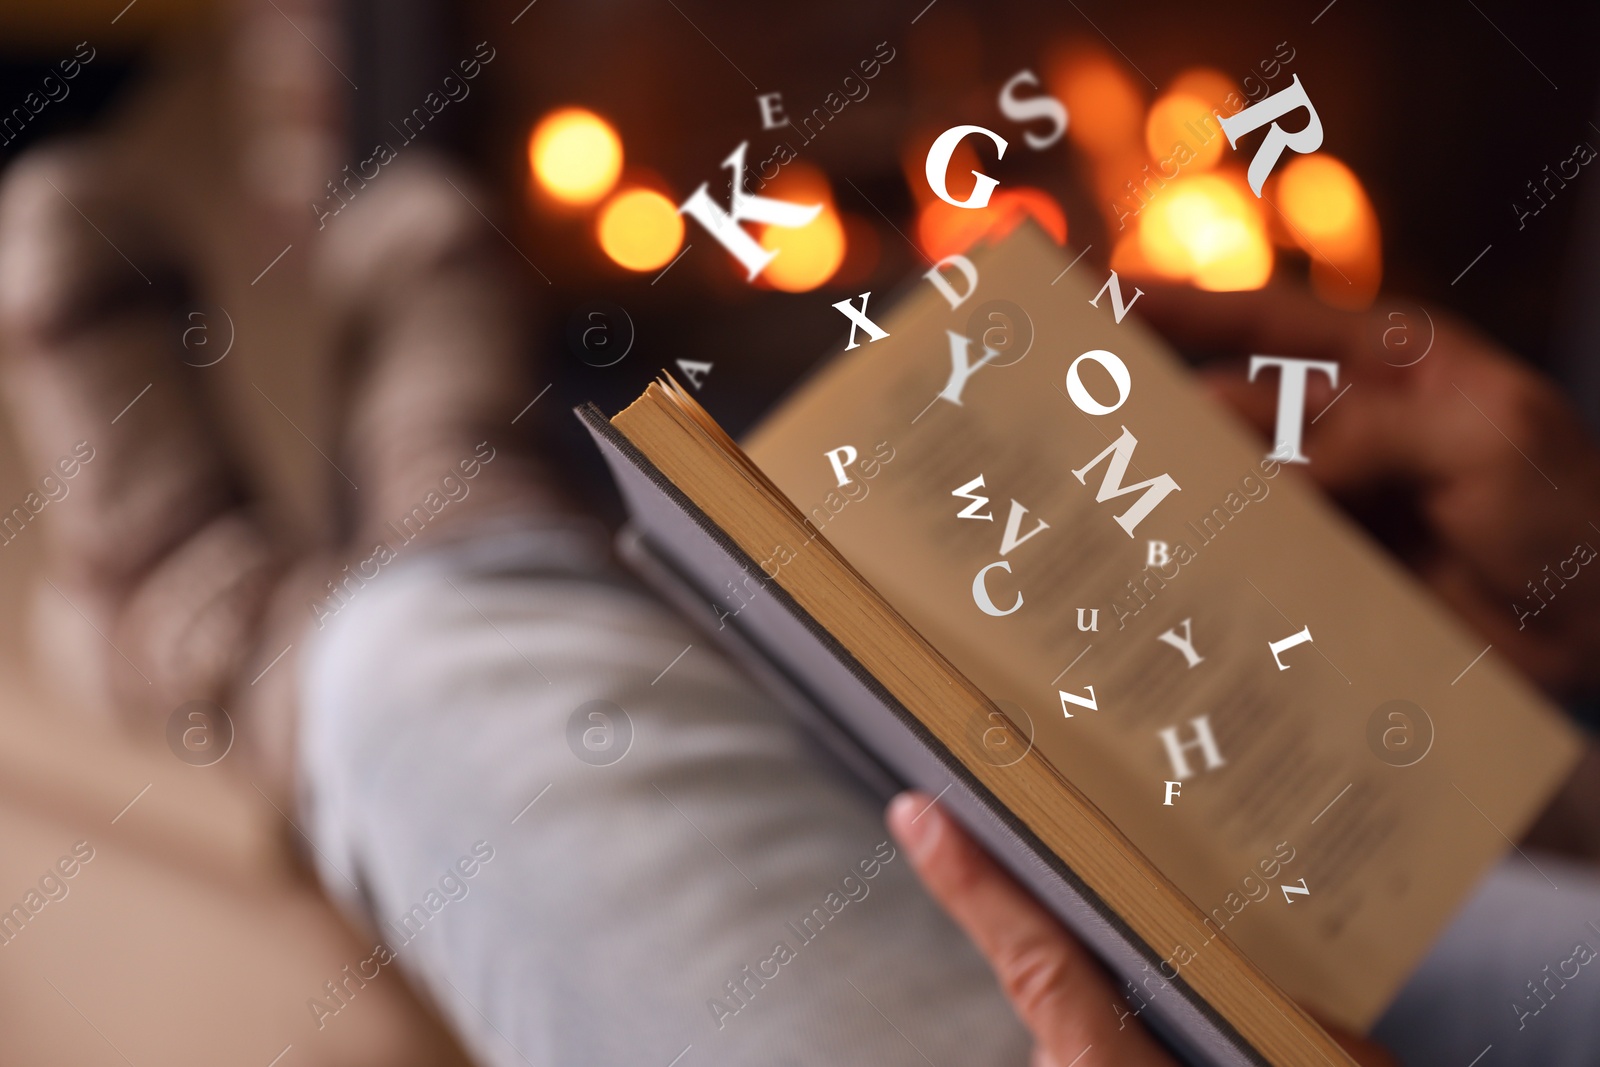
top-left (1139, 174), bottom-right (1272, 291)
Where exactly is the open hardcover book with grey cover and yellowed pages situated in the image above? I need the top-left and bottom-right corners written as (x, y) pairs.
top-left (579, 220), bottom-right (1578, 1065)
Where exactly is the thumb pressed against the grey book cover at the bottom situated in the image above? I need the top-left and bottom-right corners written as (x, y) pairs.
top-left (888, 793), bottom-right (1173, 1067)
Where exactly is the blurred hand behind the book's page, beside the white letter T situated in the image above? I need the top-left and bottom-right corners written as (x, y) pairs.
top-left (1139, 282), bottom-right (1600, 699)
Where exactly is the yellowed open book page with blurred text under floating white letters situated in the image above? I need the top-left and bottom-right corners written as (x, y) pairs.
top-left (746, 227), bottom-right (1578, 1030)
